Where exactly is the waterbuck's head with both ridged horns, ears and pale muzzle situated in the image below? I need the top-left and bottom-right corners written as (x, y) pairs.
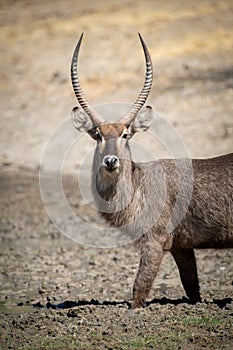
top-left (71, 34), bottom-right (153, 177)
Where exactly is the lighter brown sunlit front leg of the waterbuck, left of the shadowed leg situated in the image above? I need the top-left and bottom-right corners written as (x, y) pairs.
top-left (131, 242), bottom-right (164, 309)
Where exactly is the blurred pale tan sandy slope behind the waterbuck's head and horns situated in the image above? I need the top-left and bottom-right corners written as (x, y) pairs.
top-left (0, 0), bottom-right (233, 168)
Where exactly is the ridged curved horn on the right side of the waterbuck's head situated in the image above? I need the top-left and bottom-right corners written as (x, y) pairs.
top-left (119, 33), bottom-right (153, 124)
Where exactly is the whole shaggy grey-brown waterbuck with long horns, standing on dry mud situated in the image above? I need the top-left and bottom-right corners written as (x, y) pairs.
top-left (71, 34), bottom-right (233, 308)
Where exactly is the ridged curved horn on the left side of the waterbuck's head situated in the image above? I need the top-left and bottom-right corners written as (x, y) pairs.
top-left (71, 33), bottom-right (102, 126)
